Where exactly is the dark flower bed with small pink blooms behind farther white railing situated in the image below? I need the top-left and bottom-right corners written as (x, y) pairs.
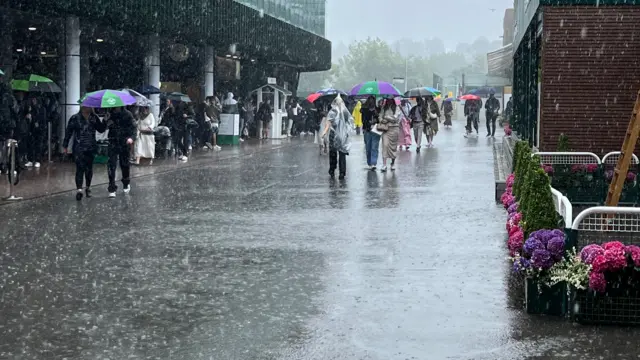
top-left (542, 164), bottom-right (606, 204)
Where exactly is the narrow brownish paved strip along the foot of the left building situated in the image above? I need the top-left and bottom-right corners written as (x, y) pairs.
top-left (0, 137), bottom-right (304, 201)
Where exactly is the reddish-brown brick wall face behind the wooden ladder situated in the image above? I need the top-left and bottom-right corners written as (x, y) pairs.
top-left (540, 6), bottom-right (640, 155)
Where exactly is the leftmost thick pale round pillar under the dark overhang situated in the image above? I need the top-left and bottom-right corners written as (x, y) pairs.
top-left (59, 16), bottom-right (80, 150)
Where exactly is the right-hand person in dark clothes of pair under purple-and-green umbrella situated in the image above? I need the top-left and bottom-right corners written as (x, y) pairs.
top-left (107, 107), bottom-right (137, 198)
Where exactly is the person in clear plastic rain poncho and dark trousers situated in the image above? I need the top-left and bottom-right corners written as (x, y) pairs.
top-left (322, 95), bottom-right (353, 180)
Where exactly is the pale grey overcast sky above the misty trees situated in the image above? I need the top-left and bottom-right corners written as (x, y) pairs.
top-left (327, 0), bottom-right (513, 50)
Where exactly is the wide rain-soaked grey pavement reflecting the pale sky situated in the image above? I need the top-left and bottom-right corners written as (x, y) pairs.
top-left (0, 114), bottom-right (640, 360)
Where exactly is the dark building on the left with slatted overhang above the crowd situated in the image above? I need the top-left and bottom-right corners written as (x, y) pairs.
top-left (0, 0), bottom-right (331, 150)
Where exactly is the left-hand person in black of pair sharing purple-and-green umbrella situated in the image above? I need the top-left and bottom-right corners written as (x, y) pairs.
top-left (62, 106), bottom-right (107, 201)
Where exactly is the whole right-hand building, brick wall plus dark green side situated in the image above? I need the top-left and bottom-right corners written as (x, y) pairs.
top-left (513, 0), bottom-right (640, 155)
